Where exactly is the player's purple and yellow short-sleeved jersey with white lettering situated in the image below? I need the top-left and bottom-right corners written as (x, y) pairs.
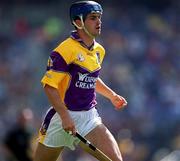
top-left (41, 32), bottom-right (105, 111)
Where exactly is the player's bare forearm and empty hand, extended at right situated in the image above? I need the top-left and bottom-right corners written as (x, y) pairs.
top-left (96, 78), bottom-right (127, 109)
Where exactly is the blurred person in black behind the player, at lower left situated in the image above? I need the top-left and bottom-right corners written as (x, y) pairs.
top-left (4, 109), bottom-right (33, 161)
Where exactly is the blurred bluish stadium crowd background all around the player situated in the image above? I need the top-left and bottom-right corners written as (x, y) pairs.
top-left (0, 0), bottom-right (180, 161)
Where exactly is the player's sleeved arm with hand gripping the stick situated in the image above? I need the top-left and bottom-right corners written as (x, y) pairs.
top-left (41, 46), bottom-right (76, 134)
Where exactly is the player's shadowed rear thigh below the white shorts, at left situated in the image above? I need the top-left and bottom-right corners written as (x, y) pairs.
top-left (33, 143), bottom-right (63, 161)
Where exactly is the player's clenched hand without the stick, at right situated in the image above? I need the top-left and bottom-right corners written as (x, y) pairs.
top-left (111, 94), bottom-right (127, 109)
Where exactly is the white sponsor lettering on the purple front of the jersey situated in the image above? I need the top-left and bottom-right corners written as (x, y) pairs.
top-left (75, 73), bottom-right (97, 89)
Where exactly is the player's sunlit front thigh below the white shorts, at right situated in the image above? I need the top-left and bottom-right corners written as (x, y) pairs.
top-left (82, 124), bottom-right (122, 161)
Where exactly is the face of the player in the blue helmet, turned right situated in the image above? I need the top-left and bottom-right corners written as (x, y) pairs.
top-left (84, 13), bottom-right (102, 37)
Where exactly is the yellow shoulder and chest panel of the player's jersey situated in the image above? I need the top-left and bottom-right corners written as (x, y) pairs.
top-left (55, 38), bottom-right (105, 72)
